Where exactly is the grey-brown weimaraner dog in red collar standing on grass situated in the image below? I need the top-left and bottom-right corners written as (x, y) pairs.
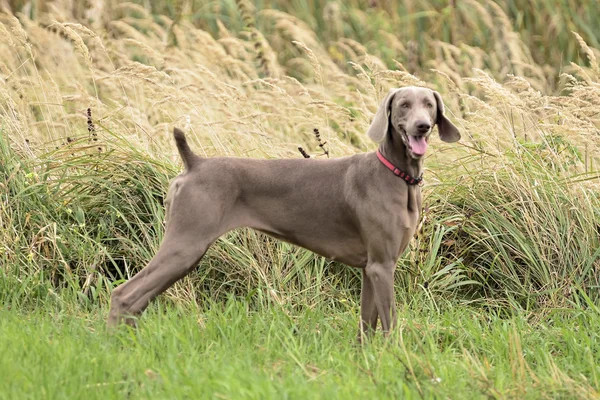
top-left (108, 87), bottom-right (460, 340)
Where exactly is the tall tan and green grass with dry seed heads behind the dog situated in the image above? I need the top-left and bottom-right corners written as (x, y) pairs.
top-left (0, 0), bottom-right (600, 308)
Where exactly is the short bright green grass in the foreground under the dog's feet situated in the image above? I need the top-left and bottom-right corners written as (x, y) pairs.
top-left (0, 299), bottom-right (600, 399)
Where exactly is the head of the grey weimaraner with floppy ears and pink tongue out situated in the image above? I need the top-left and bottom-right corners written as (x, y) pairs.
top-left (367, 86), bottom-right (460, 158)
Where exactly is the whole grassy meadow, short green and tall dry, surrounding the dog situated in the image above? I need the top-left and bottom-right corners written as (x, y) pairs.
top-left (0, 0), bottom-right (600, 399)
